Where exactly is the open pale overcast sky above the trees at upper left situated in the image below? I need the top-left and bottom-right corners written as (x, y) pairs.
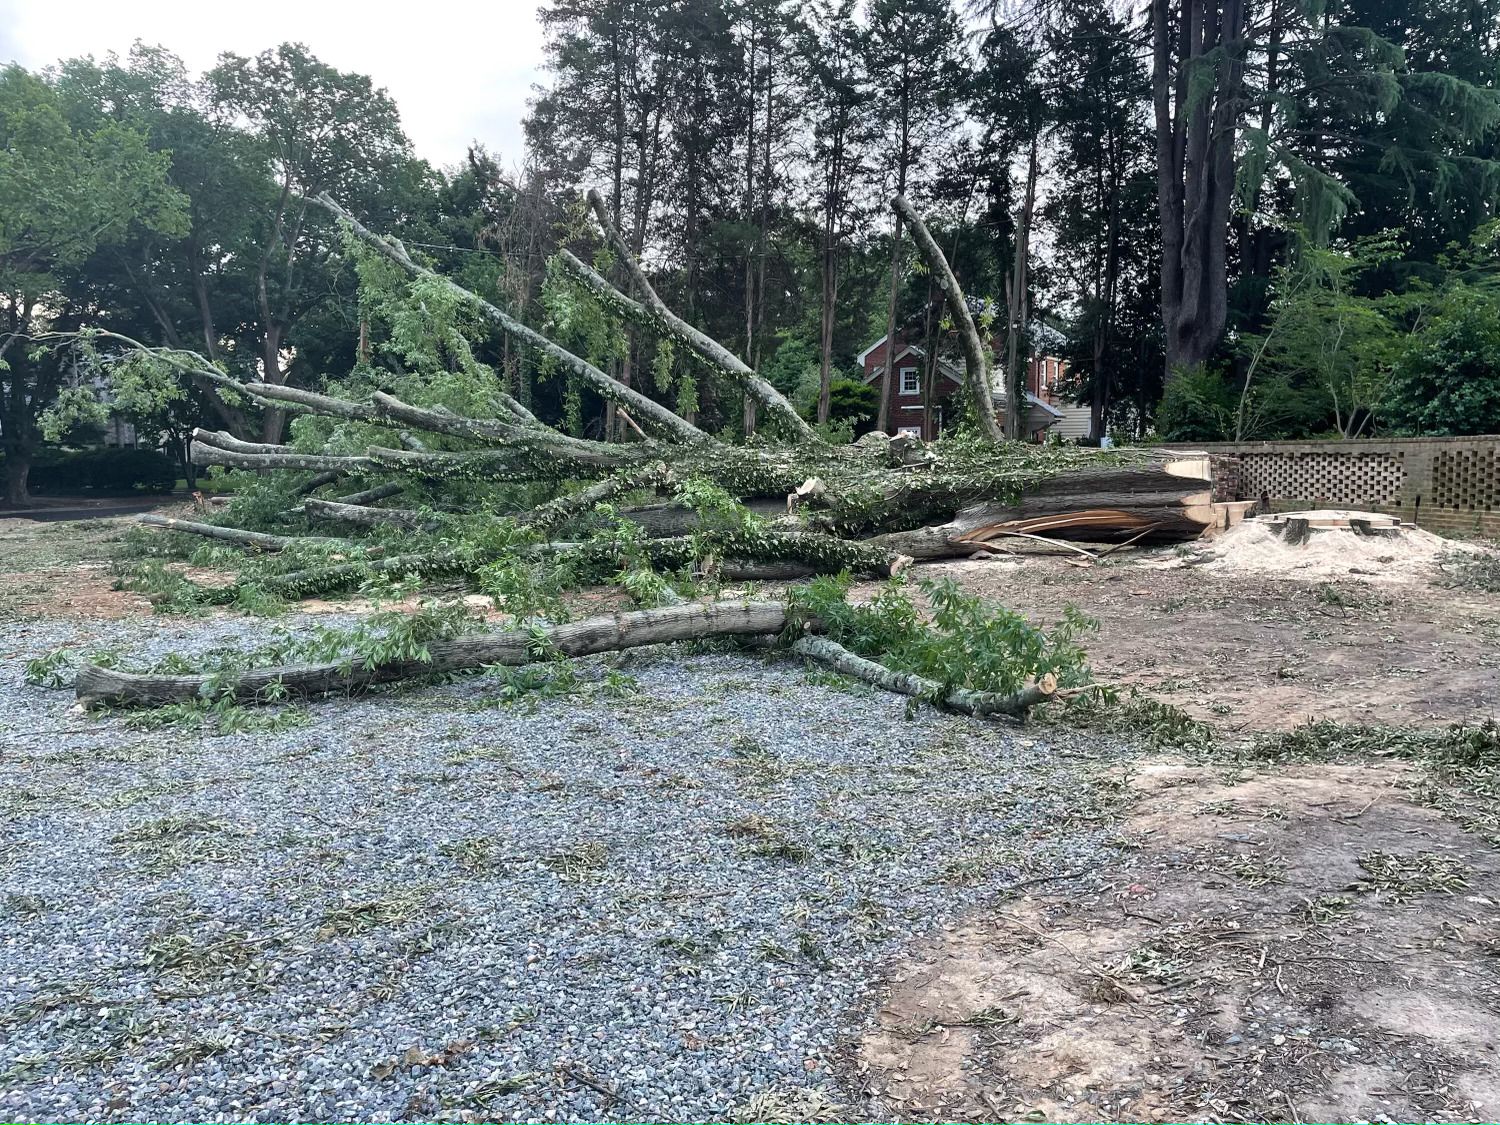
top-left (0, 0), bottom-right (542, 165)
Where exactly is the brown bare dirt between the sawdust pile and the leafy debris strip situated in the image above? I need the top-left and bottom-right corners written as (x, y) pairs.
top-left (920, 549), bottom-right (1500, 732)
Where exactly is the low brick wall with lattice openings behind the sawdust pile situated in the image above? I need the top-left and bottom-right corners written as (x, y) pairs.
top-left (1172, 435), bottom-right (1500, 536)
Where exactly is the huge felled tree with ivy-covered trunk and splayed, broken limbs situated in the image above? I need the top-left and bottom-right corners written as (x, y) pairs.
top-left (64, 195), bottom-right (1212, 716)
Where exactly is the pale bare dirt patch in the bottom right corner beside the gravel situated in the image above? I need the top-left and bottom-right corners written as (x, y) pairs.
top-left (858, 761), bottom-right (1500, 1121)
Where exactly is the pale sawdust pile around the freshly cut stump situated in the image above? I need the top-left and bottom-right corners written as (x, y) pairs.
top-left (1185, 519), bottom-right (1481, 582)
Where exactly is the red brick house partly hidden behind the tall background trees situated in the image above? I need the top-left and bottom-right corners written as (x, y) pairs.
top-left (860, 336), bottom-right (1068, 441)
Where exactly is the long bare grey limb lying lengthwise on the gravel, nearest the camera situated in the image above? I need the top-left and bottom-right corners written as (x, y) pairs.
top-left (74, 602), bottom-right (786, 707)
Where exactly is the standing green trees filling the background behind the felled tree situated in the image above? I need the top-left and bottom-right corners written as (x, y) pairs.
top-left (0, 0), bottom-right (1500, 501)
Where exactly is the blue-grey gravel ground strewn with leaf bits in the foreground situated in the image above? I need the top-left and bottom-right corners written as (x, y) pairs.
top-left (0, 618), bottom-right (1113, 1122)
